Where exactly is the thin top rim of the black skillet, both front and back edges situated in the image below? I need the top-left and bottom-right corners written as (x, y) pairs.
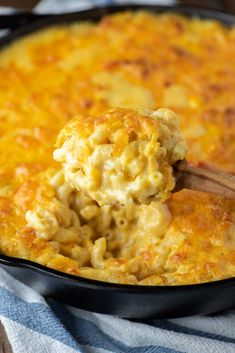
top-left (0, 4), bottom-right (235, 295)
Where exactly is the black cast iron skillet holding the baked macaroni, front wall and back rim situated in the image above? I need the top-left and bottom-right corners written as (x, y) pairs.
top-left (0, 5), bottom-right (235, 319)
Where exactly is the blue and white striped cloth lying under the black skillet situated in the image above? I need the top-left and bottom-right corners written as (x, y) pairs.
top-left (0, 0), bottom-right (235, 353)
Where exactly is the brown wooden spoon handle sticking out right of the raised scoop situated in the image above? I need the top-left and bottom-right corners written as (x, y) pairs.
top-left (173, 160), bottom-right (235, 200)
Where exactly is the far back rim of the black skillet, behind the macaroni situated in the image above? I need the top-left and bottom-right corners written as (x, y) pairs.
top-left (0, 3), bottom-right (235, 48)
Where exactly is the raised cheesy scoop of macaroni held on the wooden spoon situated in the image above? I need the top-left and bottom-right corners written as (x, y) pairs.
top-left (54, 108), bottom-right (187, 206)
